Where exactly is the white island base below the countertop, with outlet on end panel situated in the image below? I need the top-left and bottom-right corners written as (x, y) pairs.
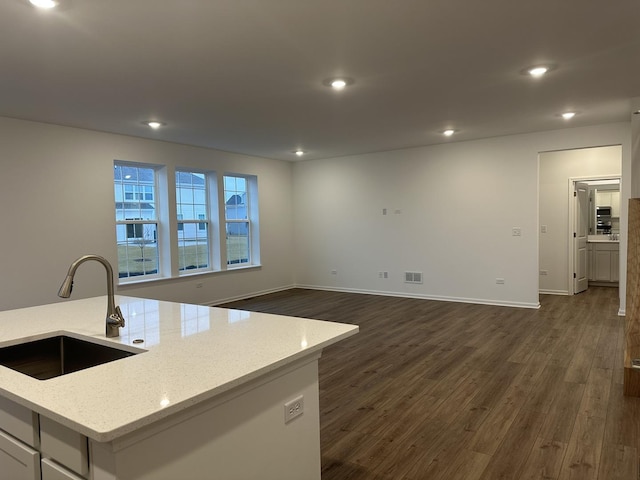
top-left (0, 352), bottom-right (320, 480)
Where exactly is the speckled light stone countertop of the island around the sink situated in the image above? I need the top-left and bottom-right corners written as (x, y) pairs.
top-left (0, 296), bottom-right (358, 442)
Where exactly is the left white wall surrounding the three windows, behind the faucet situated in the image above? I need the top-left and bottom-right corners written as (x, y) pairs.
top-left (0, 118), bottom-right (293, 310)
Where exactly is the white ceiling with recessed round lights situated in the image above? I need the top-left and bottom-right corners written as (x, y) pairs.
top-left (0, 0), bottom-right (640, 160)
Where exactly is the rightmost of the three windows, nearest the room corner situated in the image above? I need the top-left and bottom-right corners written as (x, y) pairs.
top-left (224, 175), bottom-right (251, 265)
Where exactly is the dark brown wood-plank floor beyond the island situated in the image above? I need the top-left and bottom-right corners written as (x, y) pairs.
top-left (219, 287), bottom-right (640, 480)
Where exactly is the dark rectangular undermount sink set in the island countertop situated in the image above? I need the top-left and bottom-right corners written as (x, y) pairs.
top-left (0, 335), bottom-right (140, 380)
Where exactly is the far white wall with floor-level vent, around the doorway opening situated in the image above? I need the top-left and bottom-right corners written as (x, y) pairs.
top-left (293, 123), bottom-right (631, 307)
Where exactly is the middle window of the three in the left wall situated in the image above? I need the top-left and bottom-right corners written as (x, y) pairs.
top-left (176, 171), bottom-right (211, 272)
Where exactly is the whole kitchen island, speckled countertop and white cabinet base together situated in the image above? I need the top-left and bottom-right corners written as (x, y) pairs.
top-left (0, 297), bottom-right (358, 480)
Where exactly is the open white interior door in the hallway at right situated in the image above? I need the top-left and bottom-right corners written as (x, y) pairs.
top-left (573, 182), bottom-right (589, 293)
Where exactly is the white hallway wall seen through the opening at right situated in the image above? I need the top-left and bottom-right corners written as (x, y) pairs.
top-left (540, 145), bottom-right (627, 294)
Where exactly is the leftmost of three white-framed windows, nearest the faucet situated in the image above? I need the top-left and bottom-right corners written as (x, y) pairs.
top-left (113, 162), bottom-right (159, 278)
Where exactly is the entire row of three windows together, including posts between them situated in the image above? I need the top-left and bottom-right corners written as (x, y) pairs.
top-left (113, 160), bottom-right (260, 283)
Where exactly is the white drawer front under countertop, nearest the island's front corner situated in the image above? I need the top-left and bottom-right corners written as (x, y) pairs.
top-left (40, 417), bottom-right (89, 476)
